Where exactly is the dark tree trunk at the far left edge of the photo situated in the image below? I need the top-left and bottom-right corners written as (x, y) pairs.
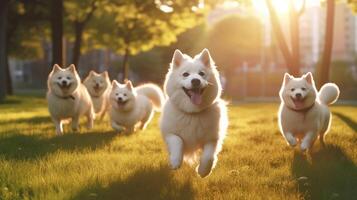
top-left (0, 1), bottom-right (9, 102)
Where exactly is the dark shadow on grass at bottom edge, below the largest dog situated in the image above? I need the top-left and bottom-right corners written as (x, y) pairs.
top-left (73, 167), bottom-right (194, 200)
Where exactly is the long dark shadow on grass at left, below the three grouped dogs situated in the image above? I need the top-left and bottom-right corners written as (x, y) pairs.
top-left (0, 132), bottom-right (117, 160)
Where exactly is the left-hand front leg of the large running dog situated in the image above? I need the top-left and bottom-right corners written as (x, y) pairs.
top-left (165, 134), bottom-right (183, 169)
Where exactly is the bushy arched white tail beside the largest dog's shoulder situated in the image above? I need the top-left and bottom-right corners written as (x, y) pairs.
top-left (135, 83), bottom-right (165, 111)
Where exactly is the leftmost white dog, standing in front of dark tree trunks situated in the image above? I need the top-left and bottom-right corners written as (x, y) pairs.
top-left (47, 64), bottom-right (95, 135)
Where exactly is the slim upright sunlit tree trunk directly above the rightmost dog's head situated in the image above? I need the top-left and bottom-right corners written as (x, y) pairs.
top-left (289, 0), bottom-right (301, 76)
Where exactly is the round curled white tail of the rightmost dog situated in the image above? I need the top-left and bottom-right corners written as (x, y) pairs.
top-left (319, 83), bottom-right (340, 105)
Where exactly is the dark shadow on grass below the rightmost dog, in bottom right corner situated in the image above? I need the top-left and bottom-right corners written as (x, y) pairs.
top-left (292, 145), bottom-right (357, 199)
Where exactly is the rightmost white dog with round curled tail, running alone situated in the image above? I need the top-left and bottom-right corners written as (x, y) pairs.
top-left (278, 72), bottom-right (340, 151)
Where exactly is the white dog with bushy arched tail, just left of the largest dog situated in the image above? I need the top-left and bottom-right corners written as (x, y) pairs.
top-left (109, 80), bottom-right (164, 133)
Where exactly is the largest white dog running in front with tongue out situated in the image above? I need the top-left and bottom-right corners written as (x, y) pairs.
top-left (160, 49), bottom-right (228, 177)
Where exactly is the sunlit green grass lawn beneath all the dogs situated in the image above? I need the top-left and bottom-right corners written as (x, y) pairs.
top-left (0, 96), bottom-right (357, 200)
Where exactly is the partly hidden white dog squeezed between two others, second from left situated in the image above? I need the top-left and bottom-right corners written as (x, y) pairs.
top-left (83, 71), bottom-right (111, 119)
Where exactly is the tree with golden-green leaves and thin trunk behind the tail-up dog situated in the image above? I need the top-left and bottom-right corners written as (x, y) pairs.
top-left (92, 0), bottom-right (203, 80)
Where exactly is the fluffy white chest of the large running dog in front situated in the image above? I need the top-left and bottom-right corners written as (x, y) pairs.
top-left (161, 101), bottom-right (225, 148)
